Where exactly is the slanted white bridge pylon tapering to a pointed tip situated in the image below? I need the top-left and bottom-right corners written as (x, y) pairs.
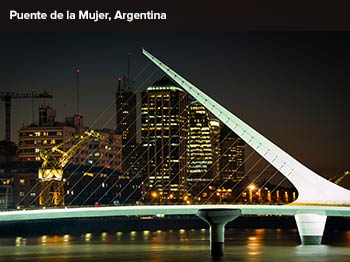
top-left (142, 49), bottom-right (350, 206)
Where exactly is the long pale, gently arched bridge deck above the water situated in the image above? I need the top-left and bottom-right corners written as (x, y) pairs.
top-left (0, 205), bottom-right (350, 222)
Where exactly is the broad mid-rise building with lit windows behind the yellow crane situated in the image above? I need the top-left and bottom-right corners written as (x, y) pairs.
top-left (17, 107), bottom-right (123, 171)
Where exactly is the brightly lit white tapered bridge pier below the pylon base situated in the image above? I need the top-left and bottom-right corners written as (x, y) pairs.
top-left (294, 214), bottom-right (327, 245)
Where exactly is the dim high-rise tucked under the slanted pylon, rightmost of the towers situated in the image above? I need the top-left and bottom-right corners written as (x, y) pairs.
top-left (220, 125), bottom-right (245, 187)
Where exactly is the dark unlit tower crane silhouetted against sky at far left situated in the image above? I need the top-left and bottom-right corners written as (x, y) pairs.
top-left (0, 92), bottom-right (52, 141)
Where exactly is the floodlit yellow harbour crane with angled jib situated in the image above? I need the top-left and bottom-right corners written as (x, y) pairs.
top-left (38, 130), bottom-right (106, 206)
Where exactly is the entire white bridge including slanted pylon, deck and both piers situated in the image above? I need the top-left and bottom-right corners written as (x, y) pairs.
top-left (0, 50), bottom-right (350, 256)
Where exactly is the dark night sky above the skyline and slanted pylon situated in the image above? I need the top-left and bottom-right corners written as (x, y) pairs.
top-left (0, 32), bottom-right (350, 186)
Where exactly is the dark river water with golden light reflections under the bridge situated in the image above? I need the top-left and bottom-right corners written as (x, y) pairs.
top-left (0, 229), bottom-right (350, 262)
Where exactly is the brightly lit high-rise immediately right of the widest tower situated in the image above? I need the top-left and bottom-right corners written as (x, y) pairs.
top-left (187, 101), bottom-right (215, 197)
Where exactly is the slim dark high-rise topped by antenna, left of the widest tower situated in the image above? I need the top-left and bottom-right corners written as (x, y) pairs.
top-left (116, 77), bottom-right (136, 176)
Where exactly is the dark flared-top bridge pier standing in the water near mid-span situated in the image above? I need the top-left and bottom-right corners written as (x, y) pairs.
top-left (197, 208), bottom-right (241, 256)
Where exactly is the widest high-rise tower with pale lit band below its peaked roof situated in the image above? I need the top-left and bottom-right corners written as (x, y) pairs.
top-left (141, 77), bottom-right (188, 202)
